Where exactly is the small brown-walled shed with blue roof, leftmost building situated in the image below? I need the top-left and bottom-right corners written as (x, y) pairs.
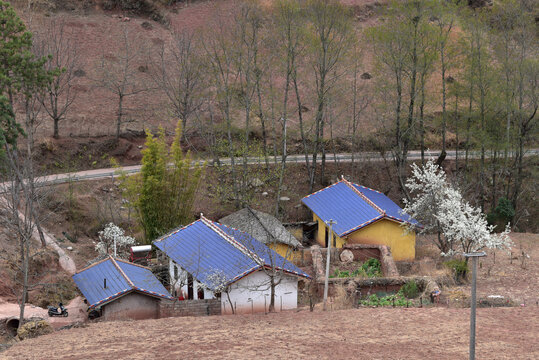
top-left (73, 256), bottom-right (173, 320)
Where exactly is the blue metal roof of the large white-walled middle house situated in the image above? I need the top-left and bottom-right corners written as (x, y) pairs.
top-left (154, 219), bottom-right (309, 291)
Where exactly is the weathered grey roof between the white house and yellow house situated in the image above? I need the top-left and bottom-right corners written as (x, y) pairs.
top-left (219, 207), bottom-right (301, 248)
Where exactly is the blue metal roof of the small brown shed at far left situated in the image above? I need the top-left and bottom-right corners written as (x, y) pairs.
top-left (73, 257), bottom-right (172, 307)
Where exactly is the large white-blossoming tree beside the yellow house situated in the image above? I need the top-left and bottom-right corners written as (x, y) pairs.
top-left (403, 161), bottom-right (512, 256)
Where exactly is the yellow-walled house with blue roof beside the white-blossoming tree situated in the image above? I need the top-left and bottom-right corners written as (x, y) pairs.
top-left (302, 178), bottom-right (419, 261)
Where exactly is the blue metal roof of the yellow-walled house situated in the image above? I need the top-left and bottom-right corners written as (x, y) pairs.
top-left (302, 180), bottom-right (417, 236)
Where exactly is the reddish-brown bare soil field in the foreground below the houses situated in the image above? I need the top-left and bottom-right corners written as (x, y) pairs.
top-left (2, 307), bottom-right (539, 359)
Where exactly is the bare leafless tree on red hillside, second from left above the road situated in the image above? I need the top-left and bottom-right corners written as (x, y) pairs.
top-left (95, 26), bottom-right (148, 140)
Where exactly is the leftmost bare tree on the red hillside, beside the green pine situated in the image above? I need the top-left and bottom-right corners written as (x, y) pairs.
top-left (33, 18), bottom-right (80, 138)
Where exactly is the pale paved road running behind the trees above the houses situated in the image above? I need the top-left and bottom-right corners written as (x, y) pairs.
top-left (27, 149), bottom-right (539, 185)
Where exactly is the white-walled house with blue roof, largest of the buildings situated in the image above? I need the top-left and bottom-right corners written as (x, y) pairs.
top-left (154, 215), bottom-right (310, 314)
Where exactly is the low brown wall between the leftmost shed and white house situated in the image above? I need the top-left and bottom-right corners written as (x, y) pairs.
top-left (159, 299), bottom-right (221, 318)
